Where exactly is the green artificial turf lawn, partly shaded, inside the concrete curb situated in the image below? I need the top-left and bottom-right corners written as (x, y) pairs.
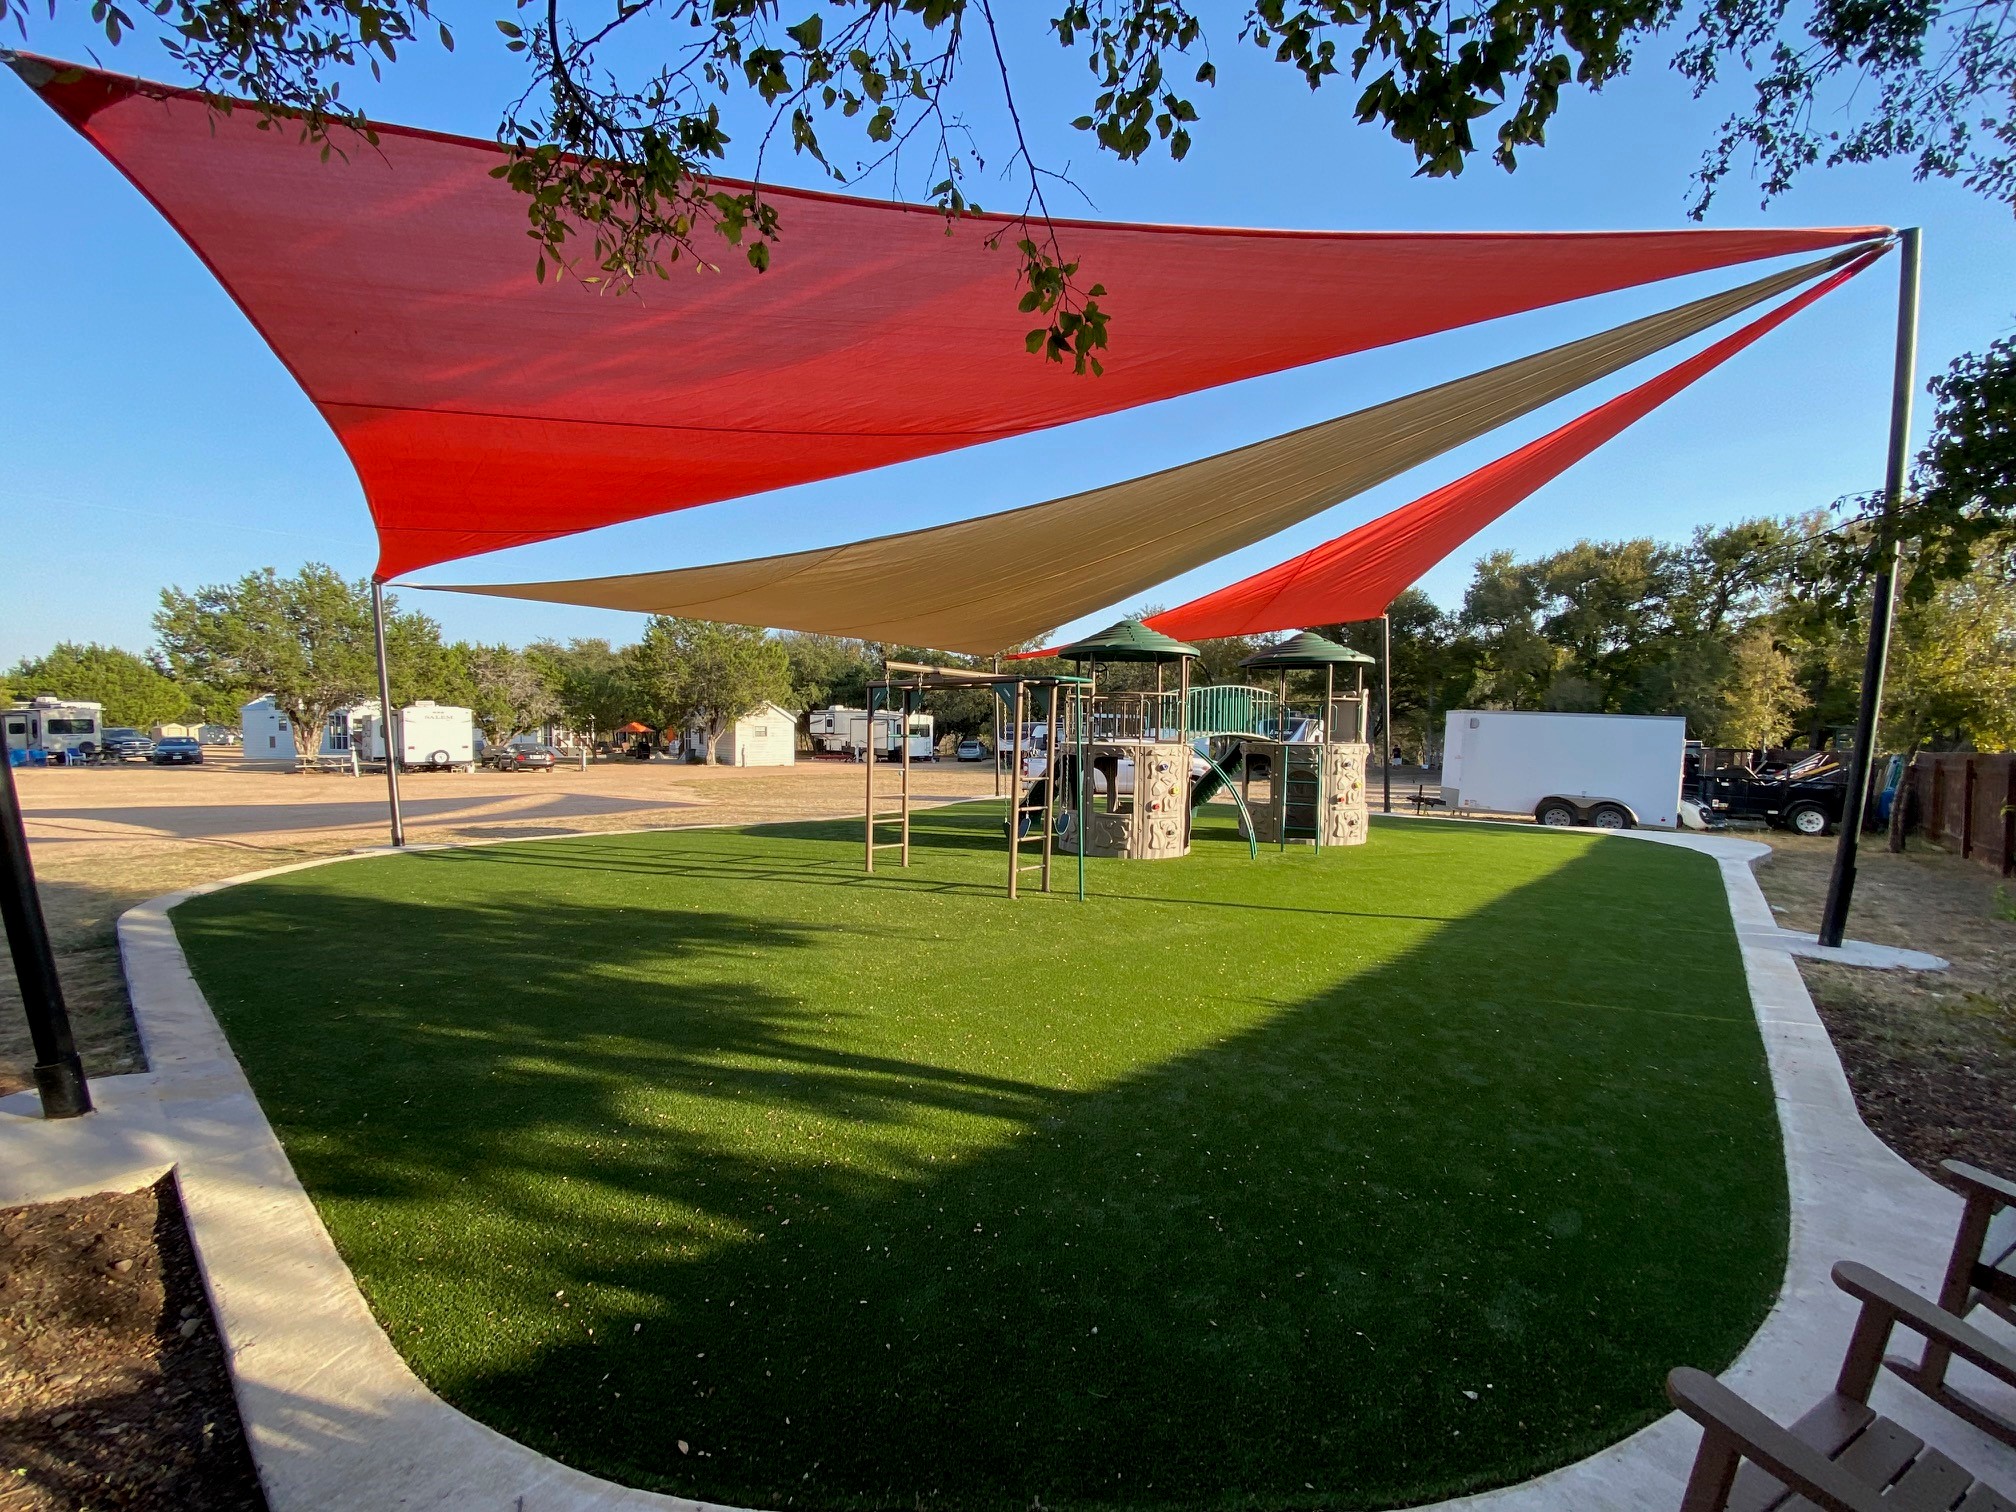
top-left (173, 806), bottom-right (1786, 1512)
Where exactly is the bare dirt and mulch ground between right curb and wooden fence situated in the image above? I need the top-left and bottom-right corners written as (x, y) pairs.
top-left (1758, 835), bottom-right (2016, 1175)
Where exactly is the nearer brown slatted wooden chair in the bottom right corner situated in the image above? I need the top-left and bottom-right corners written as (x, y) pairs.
top-left (1665, 1262), bottom-right (2016, 1512)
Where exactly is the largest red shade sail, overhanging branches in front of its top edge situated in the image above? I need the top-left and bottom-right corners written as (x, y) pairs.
top-left (14, 58), bottom-right (1883, 577)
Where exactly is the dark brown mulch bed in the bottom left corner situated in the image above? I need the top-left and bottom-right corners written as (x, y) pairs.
top-left (0, 1177), bottom-right (266, 1512)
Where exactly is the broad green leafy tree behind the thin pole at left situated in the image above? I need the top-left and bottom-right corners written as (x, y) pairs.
top-left (153, 562), bottom-right (454, 756)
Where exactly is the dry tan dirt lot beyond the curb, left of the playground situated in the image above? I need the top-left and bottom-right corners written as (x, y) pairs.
top-left (0, 758), bottom-right (994, 1093)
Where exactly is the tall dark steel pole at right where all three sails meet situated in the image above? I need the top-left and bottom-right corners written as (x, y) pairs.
top-left (1820, 226), bottom-right (1919, 946)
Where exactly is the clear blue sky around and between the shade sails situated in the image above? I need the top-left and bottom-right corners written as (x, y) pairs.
top-left (0, 0), bottom-right (2016, 663)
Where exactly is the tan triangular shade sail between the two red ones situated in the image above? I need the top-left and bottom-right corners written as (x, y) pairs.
top-left (444, 246), bottom-right (1869, 655)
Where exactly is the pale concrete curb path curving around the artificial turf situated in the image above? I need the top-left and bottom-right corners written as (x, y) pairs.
top-left (0, 827), bottom-right (2016, 1512)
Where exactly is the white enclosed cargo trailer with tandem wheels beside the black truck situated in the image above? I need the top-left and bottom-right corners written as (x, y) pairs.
top-left (1441, 710), bottom-right (1687, 829)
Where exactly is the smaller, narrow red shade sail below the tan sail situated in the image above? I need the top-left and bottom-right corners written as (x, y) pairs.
top-left (1145, 252), bottom-right (1883, 641)
